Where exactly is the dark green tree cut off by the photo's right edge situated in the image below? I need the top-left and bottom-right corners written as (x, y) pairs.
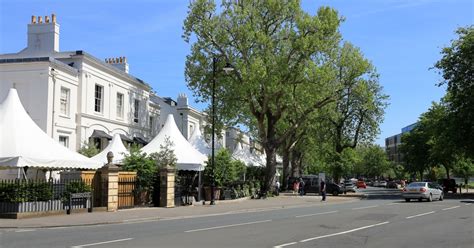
top-left (435, 26), bottom-right (474, 158)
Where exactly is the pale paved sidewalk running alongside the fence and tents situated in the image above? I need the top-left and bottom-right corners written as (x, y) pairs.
top-left (0, 195), bottom-right (358, 228)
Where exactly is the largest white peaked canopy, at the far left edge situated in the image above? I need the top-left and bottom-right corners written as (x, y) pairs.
top-left (0, 89), bottom-right (101, 169)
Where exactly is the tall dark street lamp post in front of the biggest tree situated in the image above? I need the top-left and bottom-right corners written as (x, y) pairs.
top-left (211, 57), bottom-right (234, 205)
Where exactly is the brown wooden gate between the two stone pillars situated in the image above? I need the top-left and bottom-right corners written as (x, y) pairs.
top-left (118, 172), bottom-right (136, 209)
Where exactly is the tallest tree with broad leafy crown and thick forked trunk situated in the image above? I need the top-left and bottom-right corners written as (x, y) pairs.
top-left (183, 0), bottom-right (341, 193)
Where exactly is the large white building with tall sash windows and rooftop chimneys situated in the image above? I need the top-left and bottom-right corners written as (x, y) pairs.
top-left (0, 15), bottom-right (160, 150)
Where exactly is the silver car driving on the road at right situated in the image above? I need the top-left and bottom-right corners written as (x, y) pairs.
top-left (402, 182), bottom-right (444, 202)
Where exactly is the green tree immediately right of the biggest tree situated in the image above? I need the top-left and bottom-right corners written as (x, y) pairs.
top-left (327, 42), bottom-right (388, 180)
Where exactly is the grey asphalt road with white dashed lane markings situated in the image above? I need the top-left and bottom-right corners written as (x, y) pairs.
top-left (0, 189), bottom-right (474, 248)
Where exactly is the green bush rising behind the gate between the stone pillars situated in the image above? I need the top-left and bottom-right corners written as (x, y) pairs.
top-left (122, 145), bottom-right (157, 191)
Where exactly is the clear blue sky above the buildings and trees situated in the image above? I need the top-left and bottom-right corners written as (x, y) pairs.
top-left (0, 0), bottom-right (474, 146)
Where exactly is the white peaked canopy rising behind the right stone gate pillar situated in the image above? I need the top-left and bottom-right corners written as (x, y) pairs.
top-left (141, 114), bottom-right (207, 171)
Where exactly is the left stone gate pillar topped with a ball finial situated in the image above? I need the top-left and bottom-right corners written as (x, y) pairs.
top-left (100, 152), bottom-right (119, 212)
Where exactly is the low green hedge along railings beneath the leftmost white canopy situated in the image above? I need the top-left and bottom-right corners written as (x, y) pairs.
top-left (0, 181), bottom-right (53, 203)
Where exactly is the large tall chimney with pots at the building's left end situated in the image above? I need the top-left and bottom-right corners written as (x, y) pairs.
top-left (22, 14), bottom-right (59, 54)
